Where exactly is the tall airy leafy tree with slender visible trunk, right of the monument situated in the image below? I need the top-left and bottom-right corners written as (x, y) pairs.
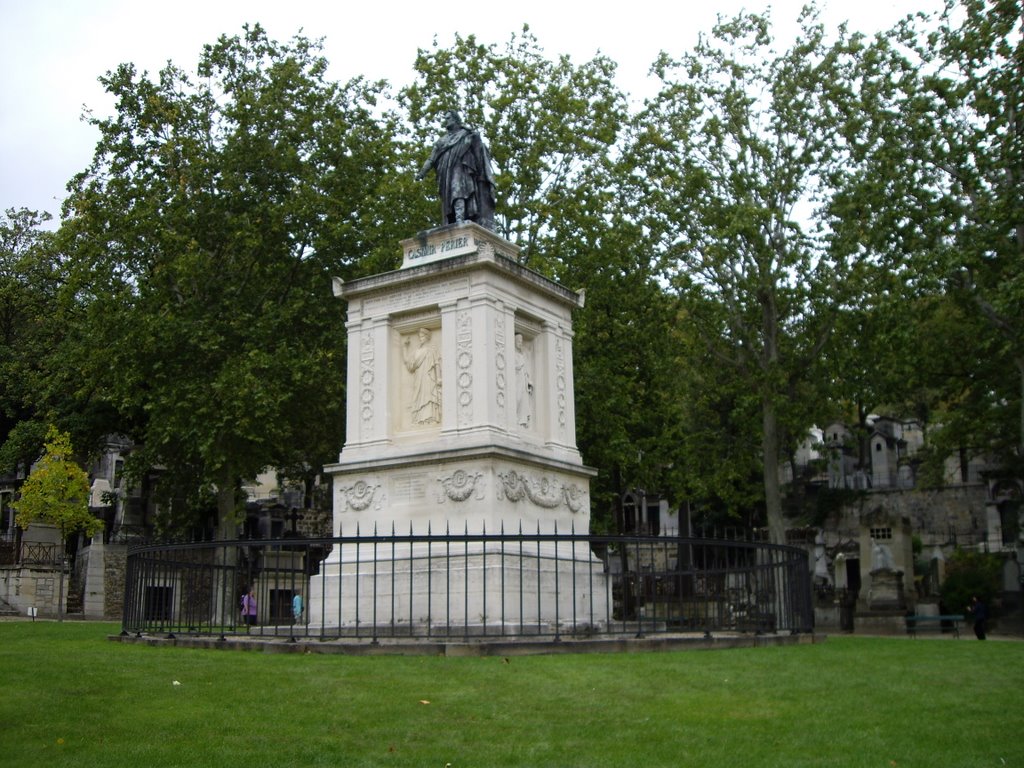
top-left (630, 10), bottom-right (897, 542)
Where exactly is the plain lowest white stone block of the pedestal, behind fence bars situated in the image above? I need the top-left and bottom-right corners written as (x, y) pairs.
top-left (309, 542), bottom-right (611, 636)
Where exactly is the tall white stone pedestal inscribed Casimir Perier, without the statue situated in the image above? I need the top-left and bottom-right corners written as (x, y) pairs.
top-left (321, 223), bottom-right (598, 636)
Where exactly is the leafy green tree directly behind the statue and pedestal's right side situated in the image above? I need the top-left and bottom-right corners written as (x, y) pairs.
top-left (400, 28), bottom-right (663, 526)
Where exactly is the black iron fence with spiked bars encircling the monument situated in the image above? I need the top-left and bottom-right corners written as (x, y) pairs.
top-left (123, 532), bottom-right (813, 640)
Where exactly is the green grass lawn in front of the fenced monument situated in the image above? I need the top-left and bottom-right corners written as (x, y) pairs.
top-left (0, 622), bottom-right (1024, 768)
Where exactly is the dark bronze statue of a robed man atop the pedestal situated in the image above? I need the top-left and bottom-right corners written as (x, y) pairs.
top-left (416, 111), bottom-right (495, 229)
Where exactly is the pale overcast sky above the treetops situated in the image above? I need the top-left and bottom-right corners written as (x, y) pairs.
top-left (0, 0), bottom-right (940, 224)
